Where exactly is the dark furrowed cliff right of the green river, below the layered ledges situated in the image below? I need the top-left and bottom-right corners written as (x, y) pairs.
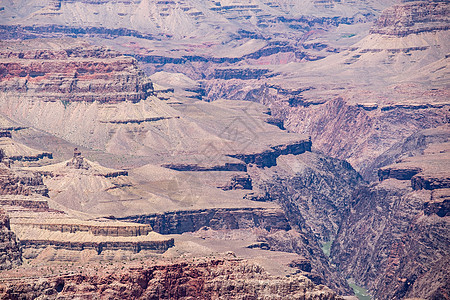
top-left (331, 179), bottom-right (450, 299)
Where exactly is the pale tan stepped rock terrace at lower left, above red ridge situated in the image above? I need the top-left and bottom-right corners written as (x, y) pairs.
top-left (0, 195), bottom-right (174, 254)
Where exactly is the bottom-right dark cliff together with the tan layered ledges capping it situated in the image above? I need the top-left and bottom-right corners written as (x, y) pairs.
top-left (331, 137), bottom-right (450, 299)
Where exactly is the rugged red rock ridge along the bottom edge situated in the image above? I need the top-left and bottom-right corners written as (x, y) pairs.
top-left (0, 259), bottom-right (342, 300)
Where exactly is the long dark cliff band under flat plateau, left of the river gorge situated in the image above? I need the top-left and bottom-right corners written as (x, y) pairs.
top-left (119, 208), bottom-right (290, 234)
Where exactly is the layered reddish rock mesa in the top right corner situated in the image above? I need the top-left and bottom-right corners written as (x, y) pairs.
top-left (371, 0), bottom-right (450, 37)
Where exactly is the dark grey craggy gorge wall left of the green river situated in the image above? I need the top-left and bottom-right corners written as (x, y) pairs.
top-left (249, 152), bottom-right (363, 242)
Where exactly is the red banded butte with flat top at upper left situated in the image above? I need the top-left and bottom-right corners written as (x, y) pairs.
top-left (0, 40), bottom-right (152, 105)
